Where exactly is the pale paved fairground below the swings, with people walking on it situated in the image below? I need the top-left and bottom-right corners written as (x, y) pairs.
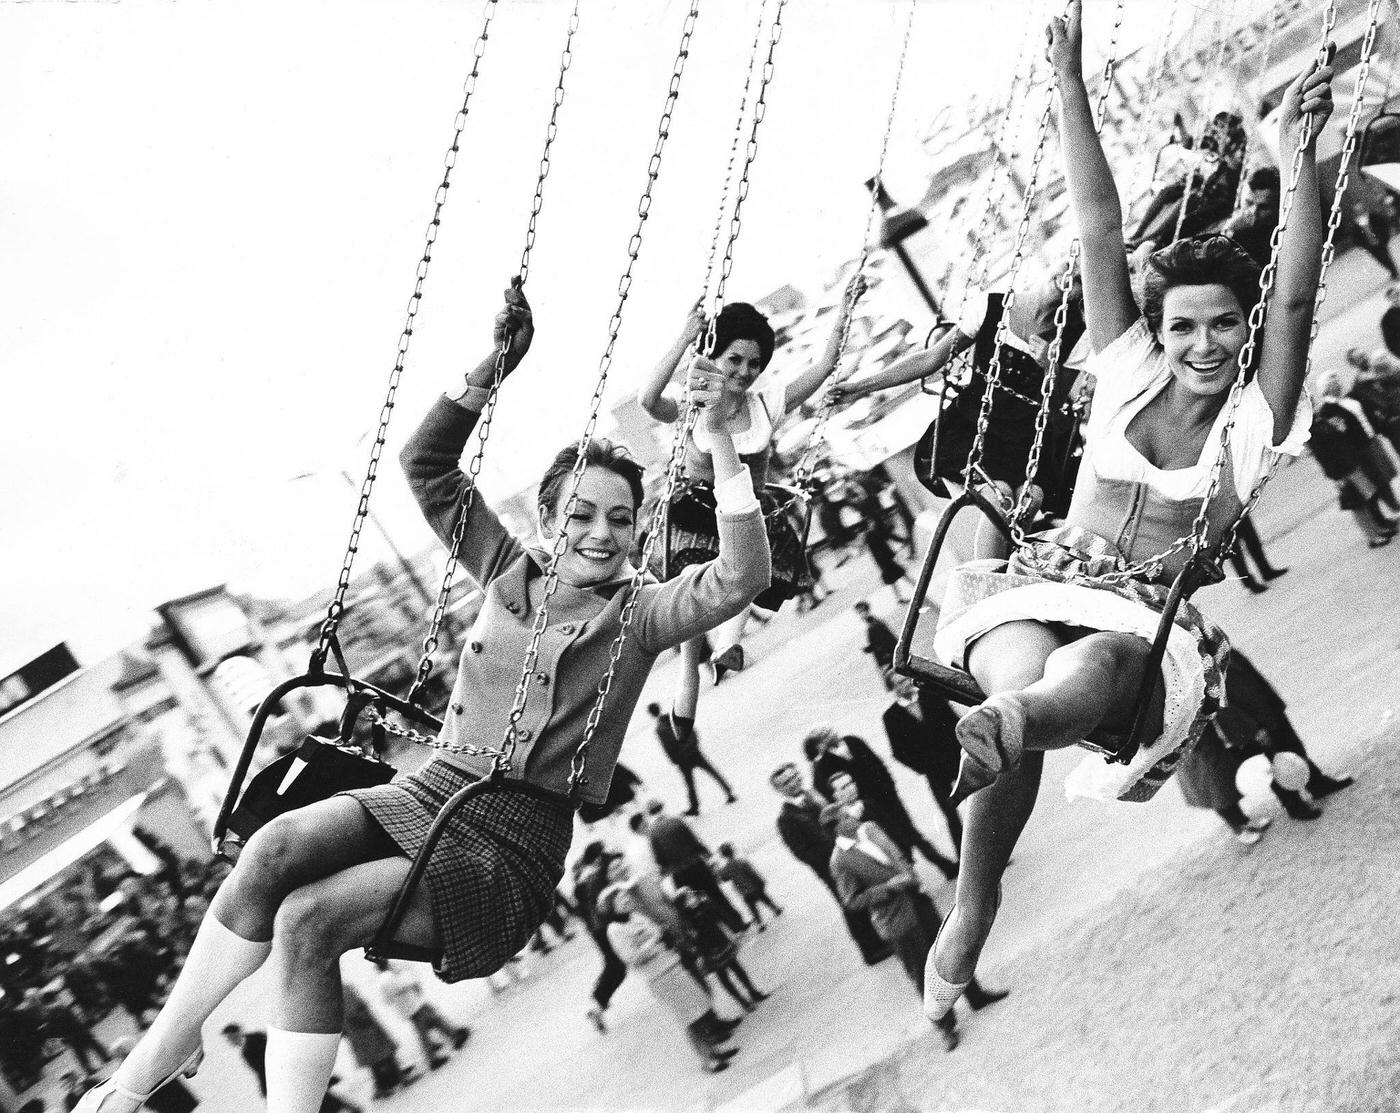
top-left (76, 239), bottom-right (1400, 1113)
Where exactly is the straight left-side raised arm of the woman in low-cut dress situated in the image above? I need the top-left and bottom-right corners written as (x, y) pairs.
top-left (1049, 0), bottom-right (1138, 351)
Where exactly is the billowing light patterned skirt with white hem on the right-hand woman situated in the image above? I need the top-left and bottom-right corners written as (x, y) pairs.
top-left (934, 526), bottom-right (1229, 801)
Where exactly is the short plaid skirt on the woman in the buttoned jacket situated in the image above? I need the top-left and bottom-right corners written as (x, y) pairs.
top-left (343, 762), bottom-right (574, 981)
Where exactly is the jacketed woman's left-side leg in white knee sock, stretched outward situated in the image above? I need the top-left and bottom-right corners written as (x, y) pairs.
top-left (84, 798), bottom-right (396, 1113)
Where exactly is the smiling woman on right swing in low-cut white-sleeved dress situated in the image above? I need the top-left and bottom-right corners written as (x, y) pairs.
top-left (924, 0), bottom-right (1331, 1018)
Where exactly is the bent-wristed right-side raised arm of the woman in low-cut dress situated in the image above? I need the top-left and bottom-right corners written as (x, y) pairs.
top-left (1256, 54), bottom-right (1331, 444)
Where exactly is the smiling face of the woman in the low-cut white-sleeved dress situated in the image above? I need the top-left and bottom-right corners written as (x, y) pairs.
top-left (1158, 286), bottom-right (1249, 395)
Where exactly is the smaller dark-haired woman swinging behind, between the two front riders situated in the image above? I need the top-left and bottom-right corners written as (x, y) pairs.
top-left (637, 289), bottom-right (864, 697)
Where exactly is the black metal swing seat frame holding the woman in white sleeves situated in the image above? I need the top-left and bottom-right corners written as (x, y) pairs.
top-left (895, 487), bottom-right (1211, 764)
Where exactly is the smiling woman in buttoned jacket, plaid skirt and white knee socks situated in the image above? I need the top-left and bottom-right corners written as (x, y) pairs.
top-left (83, 287), bottom-right (769, 1113)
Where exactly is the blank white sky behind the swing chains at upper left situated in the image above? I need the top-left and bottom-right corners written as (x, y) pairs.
top-left (0, 0), bottom-right (1165, 671)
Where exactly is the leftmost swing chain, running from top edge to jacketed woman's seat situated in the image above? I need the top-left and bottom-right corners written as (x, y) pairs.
top-left (311, 0), bottom-right (497, 672)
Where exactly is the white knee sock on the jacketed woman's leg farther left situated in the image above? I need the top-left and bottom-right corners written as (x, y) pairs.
top-left (116, 914), bottom-right (272, 1093)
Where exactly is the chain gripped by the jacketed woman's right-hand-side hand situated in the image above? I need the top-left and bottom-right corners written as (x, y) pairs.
top-left (568, 0), bottom-right (787, 794)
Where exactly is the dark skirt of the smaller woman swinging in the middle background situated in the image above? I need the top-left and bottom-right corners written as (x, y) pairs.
top-left (650, 480), bottom-right (812, 610)
